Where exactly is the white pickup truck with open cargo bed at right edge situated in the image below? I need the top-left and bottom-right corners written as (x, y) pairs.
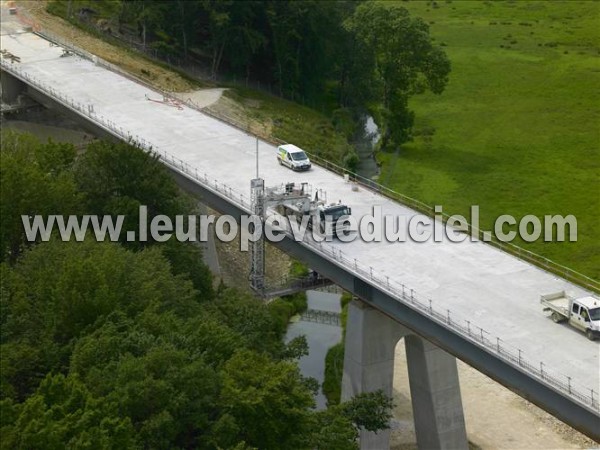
top-left (540, 291), bottom-right (600, 341)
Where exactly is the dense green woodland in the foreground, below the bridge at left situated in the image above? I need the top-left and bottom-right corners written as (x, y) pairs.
top-left (0, 132), bottom-right (391, 450)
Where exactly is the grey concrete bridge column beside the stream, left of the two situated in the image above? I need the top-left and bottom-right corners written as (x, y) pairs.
top-left (342, 300), bottom-right (409, 450)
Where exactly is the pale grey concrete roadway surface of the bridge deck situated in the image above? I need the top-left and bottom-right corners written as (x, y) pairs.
top-left (2, 33), bottom-right (600, 404)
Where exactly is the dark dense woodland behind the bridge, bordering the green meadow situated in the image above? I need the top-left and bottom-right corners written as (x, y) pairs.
top-left (49, 0), bottom-right (450, 151)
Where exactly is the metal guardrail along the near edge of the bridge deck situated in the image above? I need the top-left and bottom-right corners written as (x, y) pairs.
top-left (0, 50), bottom-right (600, 413)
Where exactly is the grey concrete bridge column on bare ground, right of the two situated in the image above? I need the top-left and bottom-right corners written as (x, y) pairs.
top-left (405, 335), bottom-right (468, 449)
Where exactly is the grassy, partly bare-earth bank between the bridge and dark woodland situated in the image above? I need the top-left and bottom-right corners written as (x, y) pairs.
top-left (38, 0), bottom-right (351, 165)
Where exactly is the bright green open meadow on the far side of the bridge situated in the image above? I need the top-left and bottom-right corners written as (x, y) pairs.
top-left (380, 1), bottom-right (600, 278)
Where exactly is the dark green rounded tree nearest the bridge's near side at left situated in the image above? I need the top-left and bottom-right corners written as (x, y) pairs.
top-left (75, 142), bottom-right (213, 300)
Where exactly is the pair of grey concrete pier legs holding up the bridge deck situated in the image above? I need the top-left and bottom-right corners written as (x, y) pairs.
top-left (342, 300), bottom-right (468, 450)
